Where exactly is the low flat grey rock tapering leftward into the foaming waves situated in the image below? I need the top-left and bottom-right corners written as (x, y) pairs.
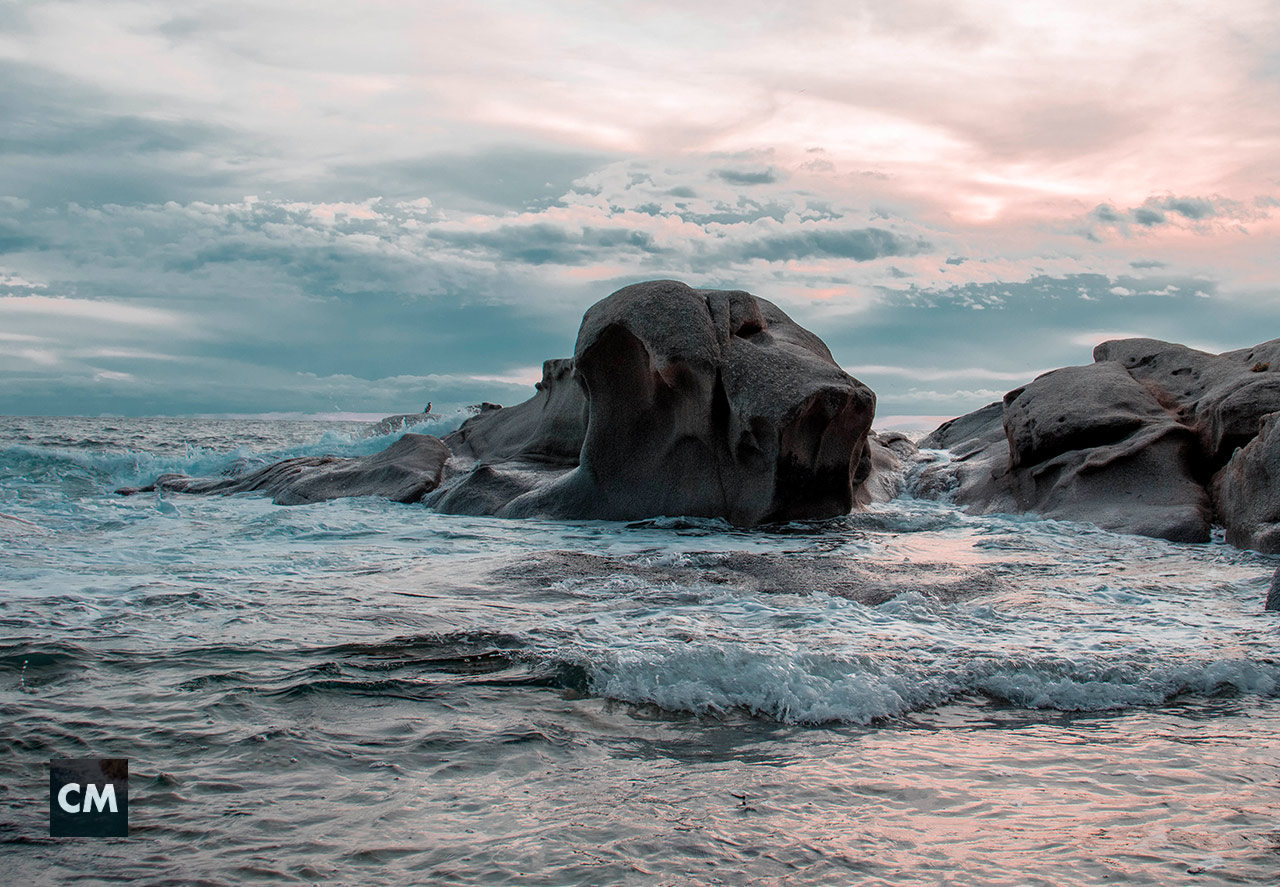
top-left (118, 434), bottom-right (449, 506)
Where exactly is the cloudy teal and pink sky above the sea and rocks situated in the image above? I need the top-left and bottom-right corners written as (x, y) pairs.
top-left (0, 0), bottom-right (1280, 419)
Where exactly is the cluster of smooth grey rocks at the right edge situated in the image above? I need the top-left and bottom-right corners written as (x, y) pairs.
top-left (916, 339), bottom-right (1280, 552)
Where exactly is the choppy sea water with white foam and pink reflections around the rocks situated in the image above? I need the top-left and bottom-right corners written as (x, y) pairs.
top-left (0, 417), bottom-right (1280, 886)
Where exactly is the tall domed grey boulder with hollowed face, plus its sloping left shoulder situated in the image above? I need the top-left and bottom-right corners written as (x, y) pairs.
top-left (460, 280), bottom-right (876, 526)
